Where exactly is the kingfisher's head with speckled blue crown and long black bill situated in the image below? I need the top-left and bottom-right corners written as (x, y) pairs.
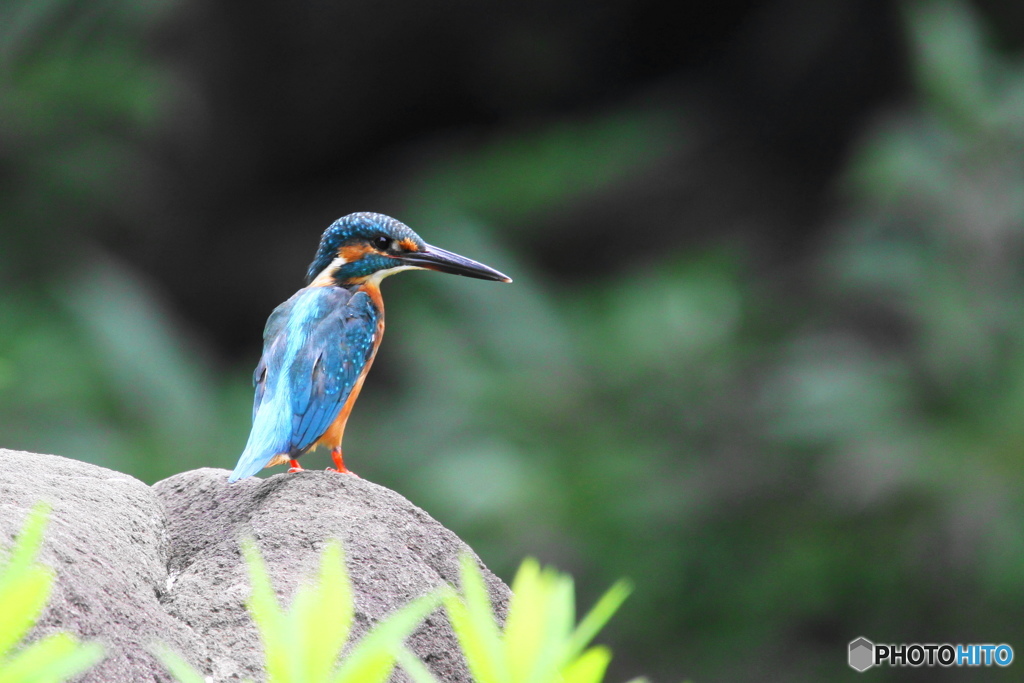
top-left (306, 213), bottom-right (512, 286)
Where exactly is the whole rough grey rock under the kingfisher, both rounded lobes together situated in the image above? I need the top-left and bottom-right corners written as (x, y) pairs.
top-left (0, 450), bottom-right (510, 682)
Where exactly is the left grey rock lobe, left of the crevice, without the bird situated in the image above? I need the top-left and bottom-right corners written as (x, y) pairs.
top-left (0, 450), bottom-right (202, 681)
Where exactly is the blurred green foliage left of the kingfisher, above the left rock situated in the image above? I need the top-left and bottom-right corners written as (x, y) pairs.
top-left (0, 0), bottom-right (249, 480)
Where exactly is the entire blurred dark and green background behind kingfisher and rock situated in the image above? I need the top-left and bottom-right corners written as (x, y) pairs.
top-left (0, 0), bottom-right (1024, 683)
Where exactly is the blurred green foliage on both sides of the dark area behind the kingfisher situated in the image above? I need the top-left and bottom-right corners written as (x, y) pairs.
top-left (0, 2), bottom-right (1024, 681)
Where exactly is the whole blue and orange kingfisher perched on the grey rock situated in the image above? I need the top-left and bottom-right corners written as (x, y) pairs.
top-left (228, 213), bottom-right (512, 482)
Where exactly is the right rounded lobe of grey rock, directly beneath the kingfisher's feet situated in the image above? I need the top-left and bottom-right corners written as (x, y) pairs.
top-left (154, 469), bottom-right (509, 681)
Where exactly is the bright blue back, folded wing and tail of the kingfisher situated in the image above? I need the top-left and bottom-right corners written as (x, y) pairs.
top-left (228, 287), bottom-right (380, 481)
